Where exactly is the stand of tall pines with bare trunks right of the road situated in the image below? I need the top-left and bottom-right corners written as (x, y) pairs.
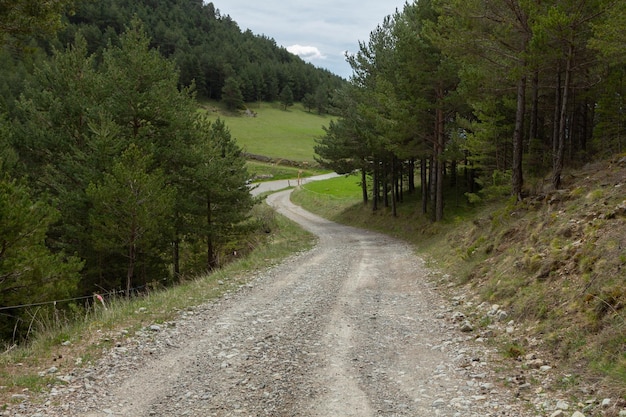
top-left (316, 0), bottom-right (626, 221)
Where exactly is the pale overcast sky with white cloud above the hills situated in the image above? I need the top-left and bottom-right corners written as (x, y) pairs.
top-left (213, 0), bottom-right (405, 79)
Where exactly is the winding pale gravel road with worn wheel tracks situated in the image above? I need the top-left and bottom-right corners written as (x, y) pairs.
top-left (8, 191), bottom-right (536, 417)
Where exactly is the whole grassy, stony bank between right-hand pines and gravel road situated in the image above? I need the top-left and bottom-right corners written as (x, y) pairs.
top-left (294, 155), bottom-right (626, 404)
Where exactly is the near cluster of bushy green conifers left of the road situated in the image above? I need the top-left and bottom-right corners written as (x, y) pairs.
top-left (0, 19), bottom-right (253, 339)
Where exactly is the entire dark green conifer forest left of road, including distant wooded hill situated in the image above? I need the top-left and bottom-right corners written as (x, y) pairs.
top-left (0, 0), bottom-right (345, 341)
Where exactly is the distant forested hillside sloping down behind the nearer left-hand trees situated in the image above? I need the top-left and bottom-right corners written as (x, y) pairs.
top-left (53, 0), bottom-right (344, 108)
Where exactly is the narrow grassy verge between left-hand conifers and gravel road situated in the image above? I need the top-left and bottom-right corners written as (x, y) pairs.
top-left (0, 204), bottom-right (314, 404)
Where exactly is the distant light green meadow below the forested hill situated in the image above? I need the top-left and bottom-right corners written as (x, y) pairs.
top-left (201, 102), bottom-right (333, 164)
